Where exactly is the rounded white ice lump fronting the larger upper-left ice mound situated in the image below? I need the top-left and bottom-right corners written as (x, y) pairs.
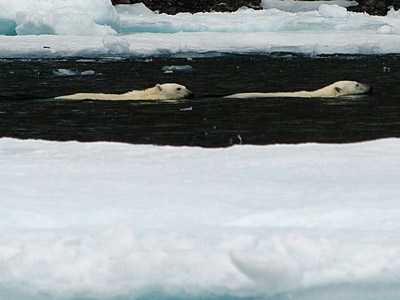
top-left (15, 8), bottom-right (117, 36)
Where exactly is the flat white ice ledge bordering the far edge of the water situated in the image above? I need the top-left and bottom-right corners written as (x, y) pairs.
top-left (0, 31), bottom-right (400, 58)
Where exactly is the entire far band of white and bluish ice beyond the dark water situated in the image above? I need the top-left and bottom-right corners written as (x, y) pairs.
top-left (0, 0), bottom-right (400, 57)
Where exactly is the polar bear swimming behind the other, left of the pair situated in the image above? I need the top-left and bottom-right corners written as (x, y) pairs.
top-left (55, 83), bottom-right (194, 100)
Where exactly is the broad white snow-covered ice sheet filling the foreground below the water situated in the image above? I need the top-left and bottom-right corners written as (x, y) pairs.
top-left (0, 138), bottom-right (400, 300)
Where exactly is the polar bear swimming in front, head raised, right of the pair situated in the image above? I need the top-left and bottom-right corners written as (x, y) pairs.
top-left (224, 80), bottom-right (372, 98)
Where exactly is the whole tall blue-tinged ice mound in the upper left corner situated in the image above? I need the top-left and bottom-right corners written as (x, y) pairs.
top-left (0, 0), bottom-right (120, 36)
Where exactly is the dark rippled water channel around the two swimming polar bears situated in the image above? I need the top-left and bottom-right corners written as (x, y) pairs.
top-left (0, 55), bottom-right (400, 147)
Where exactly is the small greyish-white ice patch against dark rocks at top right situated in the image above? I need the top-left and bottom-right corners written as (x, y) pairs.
top-left (261, 0), bottom-right (358, 12)
